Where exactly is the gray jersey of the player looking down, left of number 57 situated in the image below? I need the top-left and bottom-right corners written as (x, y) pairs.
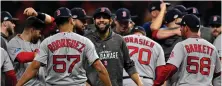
top-left (7, 35), bottom-right (43, 86)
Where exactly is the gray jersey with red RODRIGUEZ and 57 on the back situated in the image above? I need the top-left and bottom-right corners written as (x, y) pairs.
top-left (35, 32), bottom-right (98, 86)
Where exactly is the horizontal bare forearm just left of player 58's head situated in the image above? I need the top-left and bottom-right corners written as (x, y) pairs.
top-left (152, 28), bottom-right (181, 39)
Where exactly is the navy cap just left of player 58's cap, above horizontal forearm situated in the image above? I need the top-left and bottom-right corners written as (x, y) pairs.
top-left (165, 9), bottom-right (183, 24)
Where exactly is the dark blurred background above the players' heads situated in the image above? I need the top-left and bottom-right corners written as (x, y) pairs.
top-left (1, 0), bottom-right (221, 33)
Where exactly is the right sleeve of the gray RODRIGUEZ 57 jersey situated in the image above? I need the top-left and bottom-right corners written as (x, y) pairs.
top-left (84, 38), bottom-right (99, 65)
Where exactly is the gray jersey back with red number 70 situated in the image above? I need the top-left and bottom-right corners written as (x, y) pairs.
top-left (124, 35), bottom-right (165, 79)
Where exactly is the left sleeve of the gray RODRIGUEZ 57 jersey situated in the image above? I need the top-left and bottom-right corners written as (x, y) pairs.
top-left (34, 40), bottom-right (48, 65)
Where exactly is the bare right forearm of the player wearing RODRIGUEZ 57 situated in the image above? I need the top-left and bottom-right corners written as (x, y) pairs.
top-left (93, 60), bottom-right (112, 86)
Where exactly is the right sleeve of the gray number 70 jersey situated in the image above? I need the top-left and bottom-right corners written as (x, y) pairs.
top-left (157, 44), bottom-right (166, 66)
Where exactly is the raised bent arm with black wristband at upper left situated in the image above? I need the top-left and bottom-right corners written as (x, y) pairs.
top-left (23, 7), bottom-right (54, 24)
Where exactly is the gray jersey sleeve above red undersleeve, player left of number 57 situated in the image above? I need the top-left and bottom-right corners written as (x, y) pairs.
top-left (7, 40), bottom-right (24, 62)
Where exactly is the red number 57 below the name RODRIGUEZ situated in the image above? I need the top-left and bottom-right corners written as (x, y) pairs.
top-left (53, 55), bottom-right (80, 73)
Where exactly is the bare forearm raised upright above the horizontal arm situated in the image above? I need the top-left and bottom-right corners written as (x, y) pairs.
top-left (150, 3), bottom-right (166, 31)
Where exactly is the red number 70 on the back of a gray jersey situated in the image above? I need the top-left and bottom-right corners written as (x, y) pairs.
top-left (128, 46), bottom-right (152, 65)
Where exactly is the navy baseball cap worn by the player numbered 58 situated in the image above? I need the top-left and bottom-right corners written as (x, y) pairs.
top-left (176, 14), bottom-right (200, 28)
